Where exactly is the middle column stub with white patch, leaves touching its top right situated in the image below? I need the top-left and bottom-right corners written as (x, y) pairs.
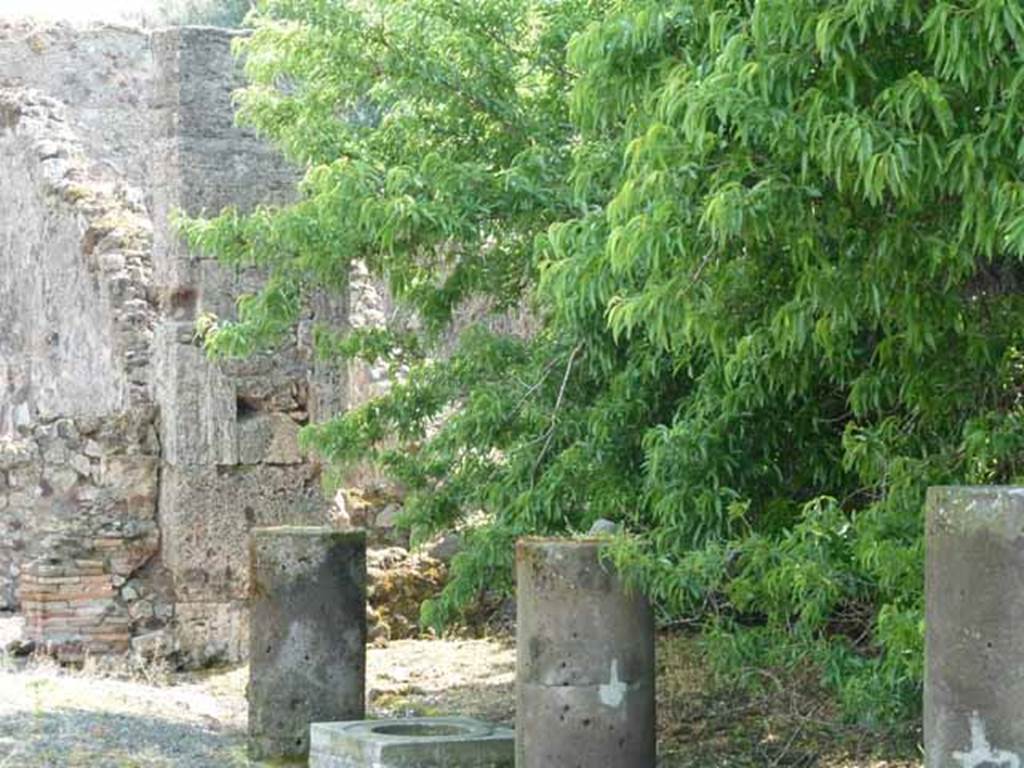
top-left (515, 539), bottom-right (654, 768)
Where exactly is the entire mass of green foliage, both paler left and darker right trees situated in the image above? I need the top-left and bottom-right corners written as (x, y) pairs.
top-left (188, 0), bottom-right (1024, 721)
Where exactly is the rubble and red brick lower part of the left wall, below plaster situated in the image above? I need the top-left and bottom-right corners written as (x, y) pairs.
top-left (0, 412), bottom-right (162, 658)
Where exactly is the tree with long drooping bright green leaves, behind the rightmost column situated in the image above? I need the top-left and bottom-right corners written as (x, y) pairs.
top-left (565, 0), bottom-right (1024, 719)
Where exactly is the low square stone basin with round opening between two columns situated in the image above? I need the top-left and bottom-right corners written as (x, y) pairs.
top-left (309, 717), bottom-right (515, 768)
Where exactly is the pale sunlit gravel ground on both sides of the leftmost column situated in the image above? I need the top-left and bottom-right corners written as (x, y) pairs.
top-left (0, 618), bottom-right (515, 768)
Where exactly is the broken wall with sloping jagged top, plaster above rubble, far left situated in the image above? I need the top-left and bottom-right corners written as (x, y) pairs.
top-left (0, 88), bottom-right (159, 652)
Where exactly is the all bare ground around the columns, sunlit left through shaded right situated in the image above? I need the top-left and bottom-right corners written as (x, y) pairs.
top-left (0, 618), bottom-right (921, 768)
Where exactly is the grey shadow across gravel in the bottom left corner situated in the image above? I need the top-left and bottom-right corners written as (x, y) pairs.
top-left (0, 709), bottom-right (251, 768)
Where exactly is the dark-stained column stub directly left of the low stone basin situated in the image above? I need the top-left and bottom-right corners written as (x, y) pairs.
top-left (249, 527), bottom-right (367, 760)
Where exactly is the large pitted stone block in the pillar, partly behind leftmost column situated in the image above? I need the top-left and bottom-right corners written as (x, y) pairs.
top-left (160, 464), bottom-right (329, 602)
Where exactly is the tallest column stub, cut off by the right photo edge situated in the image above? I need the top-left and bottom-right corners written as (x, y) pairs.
top-left (925, 486), bottom-right (1024, 768)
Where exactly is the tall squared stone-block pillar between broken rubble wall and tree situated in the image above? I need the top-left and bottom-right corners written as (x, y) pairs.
top-left (151, 29), bottom-right (339, 662)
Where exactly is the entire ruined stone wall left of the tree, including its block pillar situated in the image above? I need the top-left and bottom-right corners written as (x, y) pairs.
top-left (0, 25), bottom-right (347, 665)
